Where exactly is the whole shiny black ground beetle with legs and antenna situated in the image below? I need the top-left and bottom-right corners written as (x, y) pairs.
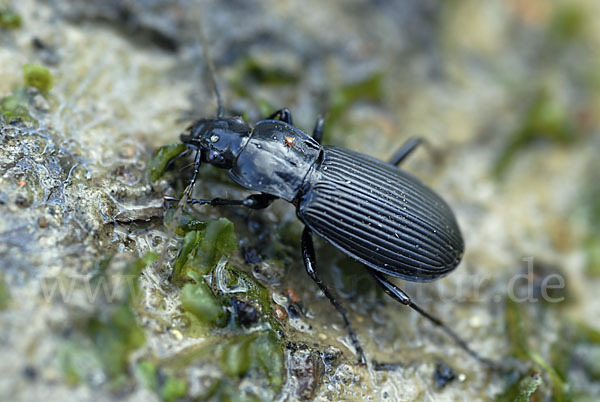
top-left (165, 37), bottom-right (495, 366)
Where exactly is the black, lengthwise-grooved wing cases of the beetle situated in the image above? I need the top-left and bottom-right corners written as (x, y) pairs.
top-left (298, 147), bottom-right (464, 281)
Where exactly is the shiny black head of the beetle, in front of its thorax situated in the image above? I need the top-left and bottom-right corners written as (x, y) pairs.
top-left (181, 117), bottom-right (252, 169)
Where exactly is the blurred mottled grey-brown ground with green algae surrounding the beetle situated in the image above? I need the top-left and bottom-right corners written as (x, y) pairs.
top-left (0, 0), bottom-right (600, 401)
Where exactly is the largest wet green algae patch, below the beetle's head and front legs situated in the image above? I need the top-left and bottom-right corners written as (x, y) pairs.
top-left (164, 218), bottom-right (285, 400)
